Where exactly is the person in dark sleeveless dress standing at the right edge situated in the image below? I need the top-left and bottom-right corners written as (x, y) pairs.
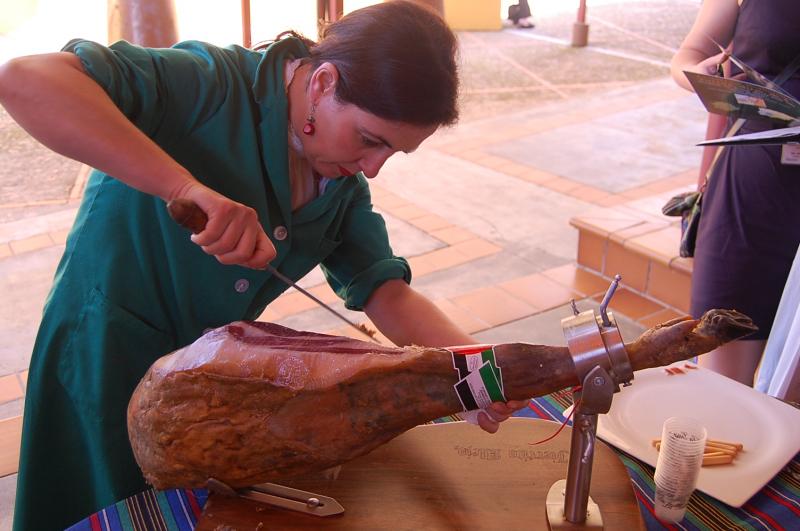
top-left (672, 0), bottom-right (800, 385)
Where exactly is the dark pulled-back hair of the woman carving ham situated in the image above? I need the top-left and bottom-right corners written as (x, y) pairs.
top-left (278, 0), bottom-right (458, 126)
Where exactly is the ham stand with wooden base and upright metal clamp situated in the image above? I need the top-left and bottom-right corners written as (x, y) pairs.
top-left (197, 275), bottom-right (644, 531)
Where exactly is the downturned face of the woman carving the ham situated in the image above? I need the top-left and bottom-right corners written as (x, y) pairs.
top-left (295, 63), bottom-right (437, 178)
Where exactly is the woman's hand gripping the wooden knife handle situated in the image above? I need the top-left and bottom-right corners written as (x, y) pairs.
top-left (171, 182), bottom-right (277, 269)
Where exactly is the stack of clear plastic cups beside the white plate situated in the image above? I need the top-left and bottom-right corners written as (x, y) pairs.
top-left (655, 417), bottom-right (706, 523)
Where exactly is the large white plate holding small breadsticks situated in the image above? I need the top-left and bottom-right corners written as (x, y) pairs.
top-left (597, 363), bottom-right (800, 507)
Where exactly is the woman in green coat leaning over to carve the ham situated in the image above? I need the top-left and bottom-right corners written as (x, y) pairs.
top-left (0, 2), bottom-right (521, 531)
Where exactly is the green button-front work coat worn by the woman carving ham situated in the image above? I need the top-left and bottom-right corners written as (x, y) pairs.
top-left (14, 38), bottom-right (411, 531)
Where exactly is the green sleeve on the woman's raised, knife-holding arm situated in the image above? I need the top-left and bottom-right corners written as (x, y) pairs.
top-left (62, 39), bottom-right (250, 141)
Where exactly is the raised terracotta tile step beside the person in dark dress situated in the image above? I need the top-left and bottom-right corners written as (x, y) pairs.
top-left (570, 190), bottom-right (692, 314)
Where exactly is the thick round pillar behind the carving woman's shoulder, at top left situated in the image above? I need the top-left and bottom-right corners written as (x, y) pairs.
top-left (108, 0), bottom-right (178, 48)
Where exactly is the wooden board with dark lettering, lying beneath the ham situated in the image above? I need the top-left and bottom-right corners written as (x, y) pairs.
top-left (197, 418), bottom-right (645, 531)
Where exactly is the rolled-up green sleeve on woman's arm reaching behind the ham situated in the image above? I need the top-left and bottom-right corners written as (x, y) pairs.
top-left (322, 176), bottom-right (411, 310)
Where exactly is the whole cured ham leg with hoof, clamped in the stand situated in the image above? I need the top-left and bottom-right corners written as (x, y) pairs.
top-left (128, 310), bottom-right (755, 489)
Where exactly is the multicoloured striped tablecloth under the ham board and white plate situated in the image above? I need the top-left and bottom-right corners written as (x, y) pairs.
top-left (68, 391), bottom-right (800, 531)
